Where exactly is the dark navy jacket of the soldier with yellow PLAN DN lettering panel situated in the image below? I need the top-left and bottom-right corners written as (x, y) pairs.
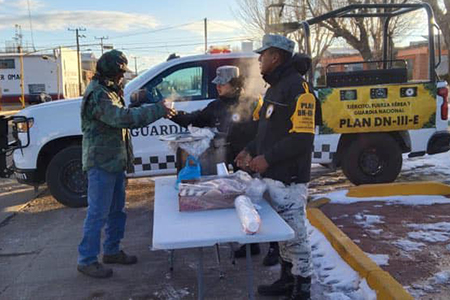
top-left (246, 60), bottom-right (321, 184)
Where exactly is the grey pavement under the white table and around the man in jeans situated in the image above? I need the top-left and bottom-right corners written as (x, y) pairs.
top-left (0, 180), bottom-right (286, 300)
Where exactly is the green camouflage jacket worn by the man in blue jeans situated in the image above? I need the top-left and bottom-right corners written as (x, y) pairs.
top-left (81, 79), bottom-right (165, 172)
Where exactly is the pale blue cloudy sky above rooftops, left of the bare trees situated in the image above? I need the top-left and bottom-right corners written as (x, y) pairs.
top-left (0, 0), bottom-right (260, 71)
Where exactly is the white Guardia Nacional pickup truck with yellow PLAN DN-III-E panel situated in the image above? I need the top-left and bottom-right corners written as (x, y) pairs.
top-left (0, 49), bottom-right (450, 207)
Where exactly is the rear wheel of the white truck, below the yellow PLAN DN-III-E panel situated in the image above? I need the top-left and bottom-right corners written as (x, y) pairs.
top-left (341, 133), bottom-right (402, 185)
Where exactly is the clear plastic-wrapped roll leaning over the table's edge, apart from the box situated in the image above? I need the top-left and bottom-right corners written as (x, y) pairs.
top-left (234, 195), bottom-right (261, 234)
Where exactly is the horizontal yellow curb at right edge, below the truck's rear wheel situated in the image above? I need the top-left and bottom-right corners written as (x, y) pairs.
top-left (346, 181), bottom-right (450, 198)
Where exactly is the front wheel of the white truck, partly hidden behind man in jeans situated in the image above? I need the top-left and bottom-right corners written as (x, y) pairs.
top-left (46, 146), bottom-right (87, 207)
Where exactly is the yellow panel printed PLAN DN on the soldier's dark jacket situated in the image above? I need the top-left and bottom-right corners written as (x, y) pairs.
top-left (289, 82), bottom-right (316, 134)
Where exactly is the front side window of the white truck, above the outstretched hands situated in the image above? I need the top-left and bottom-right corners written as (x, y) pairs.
top-left (144, 66), bottom-right (206, 103)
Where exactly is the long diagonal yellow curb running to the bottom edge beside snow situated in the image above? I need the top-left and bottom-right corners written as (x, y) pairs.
top-left (307, 204), bottom-right (413, 300)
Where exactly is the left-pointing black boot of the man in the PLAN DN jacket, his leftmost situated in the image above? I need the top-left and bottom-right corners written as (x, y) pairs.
top-left (258, 259), bottom-right (294, 296)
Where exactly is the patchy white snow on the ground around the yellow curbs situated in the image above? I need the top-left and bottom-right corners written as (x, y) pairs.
top-left (309, 153), bottom-right (450, 300)
